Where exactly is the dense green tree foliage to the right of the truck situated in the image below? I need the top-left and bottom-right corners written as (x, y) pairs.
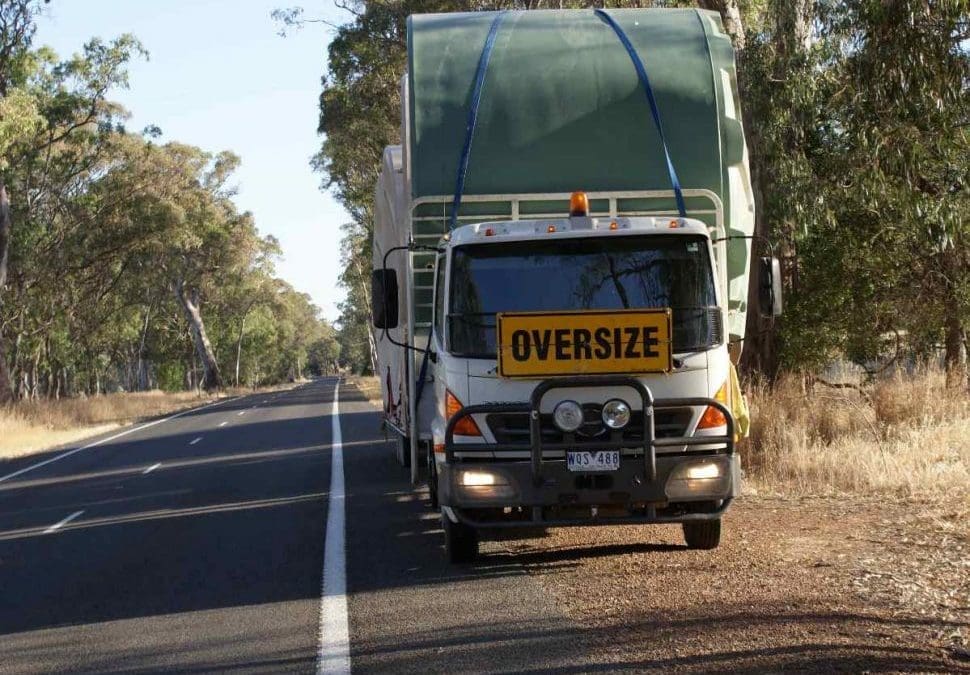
top-left (745, 0), bottom-right (970, 368)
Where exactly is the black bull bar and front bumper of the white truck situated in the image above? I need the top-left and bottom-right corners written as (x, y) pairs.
top-left (438, 376), bottom-right (741, 528)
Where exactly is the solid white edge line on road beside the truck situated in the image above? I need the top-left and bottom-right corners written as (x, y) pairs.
top-left (317, 383), bottom-right (350, 674)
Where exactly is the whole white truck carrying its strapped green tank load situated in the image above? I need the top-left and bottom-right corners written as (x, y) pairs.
top-left (371, 9), bottom-right (781, 563)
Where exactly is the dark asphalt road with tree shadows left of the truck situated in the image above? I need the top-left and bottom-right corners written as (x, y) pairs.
top-left (0, 378), bottom-right (588, 673)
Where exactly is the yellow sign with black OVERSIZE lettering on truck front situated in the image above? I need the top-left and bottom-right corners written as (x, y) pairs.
top-left (497, 309), bottom-right (672, 377)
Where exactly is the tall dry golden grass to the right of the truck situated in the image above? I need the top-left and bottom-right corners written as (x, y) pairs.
top-left (742, 371), bottom-right (970, 502)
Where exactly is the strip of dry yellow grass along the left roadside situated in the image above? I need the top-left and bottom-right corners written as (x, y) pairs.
top-left (0, 385), bottom-right (292, 459)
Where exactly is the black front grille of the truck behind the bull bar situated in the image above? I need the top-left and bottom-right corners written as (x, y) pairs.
top-left (485, 405), bottom-right (693, 447)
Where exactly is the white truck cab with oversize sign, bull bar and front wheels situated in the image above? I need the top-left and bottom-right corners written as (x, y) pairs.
top-left (420, 209), bottom-right (740, 560)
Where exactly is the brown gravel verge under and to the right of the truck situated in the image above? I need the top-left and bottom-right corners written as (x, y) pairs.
top-left (486, 496), bottom-right (970, 673)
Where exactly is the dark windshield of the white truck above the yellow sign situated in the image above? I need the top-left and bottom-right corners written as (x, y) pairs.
top-left (448, 235), bottom-right (721, 358)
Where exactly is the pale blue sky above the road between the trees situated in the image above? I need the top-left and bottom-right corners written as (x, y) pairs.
top-left (34, 0), bottom-right (350, 320)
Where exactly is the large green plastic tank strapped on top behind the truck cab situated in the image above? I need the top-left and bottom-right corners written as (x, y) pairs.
top-left (408, 9), bottom-right (753, 335)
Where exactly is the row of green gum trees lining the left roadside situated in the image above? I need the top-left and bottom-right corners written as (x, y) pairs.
top-left (0, 11), bottom-right (337, 397)
